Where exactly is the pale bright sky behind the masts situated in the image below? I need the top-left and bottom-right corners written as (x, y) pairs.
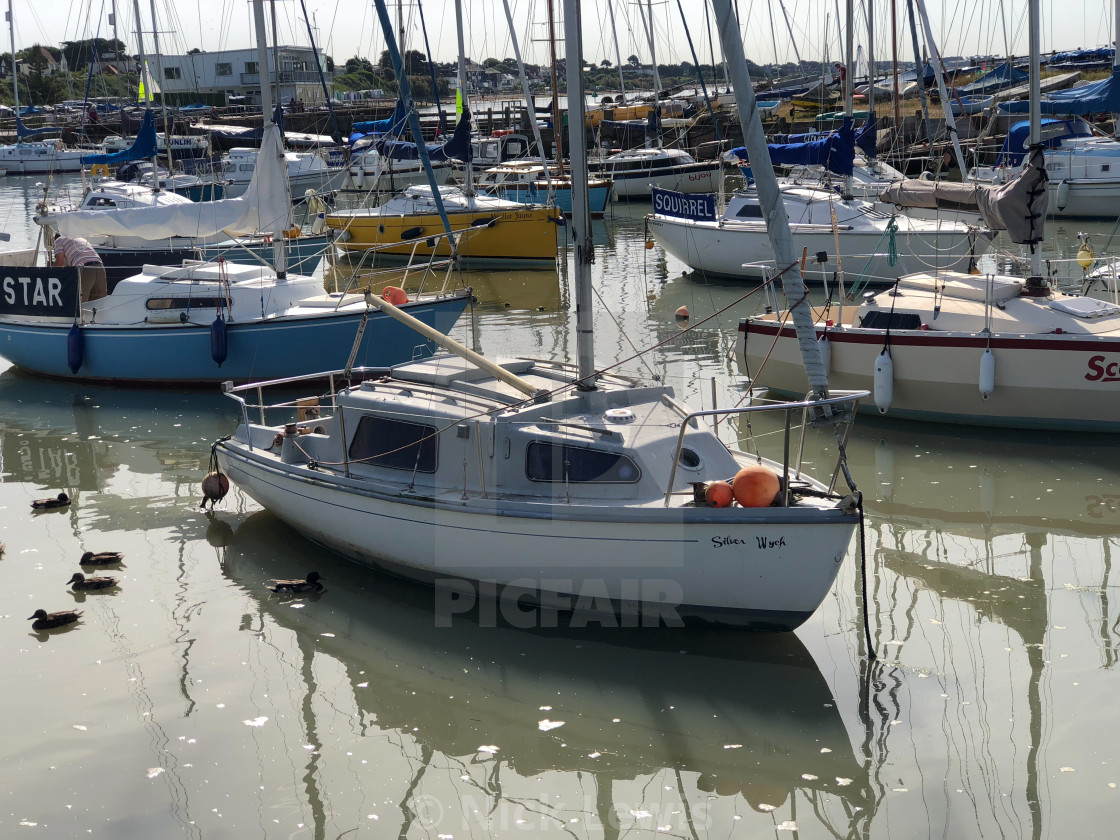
top-left (10, 0), bottom-right (1113, 70)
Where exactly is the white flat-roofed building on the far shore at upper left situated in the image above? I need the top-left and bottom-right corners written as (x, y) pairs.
top-left (156, 46), bottom-right (334, 105)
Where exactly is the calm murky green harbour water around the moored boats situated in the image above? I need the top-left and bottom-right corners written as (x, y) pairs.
top-left (0, 178), bottom-right (1120, 840)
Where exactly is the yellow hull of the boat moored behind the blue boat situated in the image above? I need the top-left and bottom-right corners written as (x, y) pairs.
top-left (326, 207), bottom-right (558, 265)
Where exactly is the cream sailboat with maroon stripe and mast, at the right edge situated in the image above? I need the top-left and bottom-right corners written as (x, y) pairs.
top-left (737, 0), bottom-right (1120, 431)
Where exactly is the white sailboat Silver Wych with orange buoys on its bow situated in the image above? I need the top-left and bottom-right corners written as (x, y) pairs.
top-left (214, 0), bottom-right (866, 629)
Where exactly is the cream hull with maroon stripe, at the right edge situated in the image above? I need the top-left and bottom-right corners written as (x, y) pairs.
top-left (736, 319), bottom-right (1120, 432)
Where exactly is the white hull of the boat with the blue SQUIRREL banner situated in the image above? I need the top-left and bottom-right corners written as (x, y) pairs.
top-left (646, 215), bottom-right (976, 288)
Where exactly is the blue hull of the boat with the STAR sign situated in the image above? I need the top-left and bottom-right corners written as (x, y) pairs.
top-left (0, 295), bottom-right (469, 385)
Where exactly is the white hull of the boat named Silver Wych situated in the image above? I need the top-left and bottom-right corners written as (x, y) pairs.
top-left (217, 448), bottom-right (856, 631)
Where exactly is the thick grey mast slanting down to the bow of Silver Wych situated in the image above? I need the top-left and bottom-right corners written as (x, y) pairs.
top-left (712, 0), bottom-right (829, 398)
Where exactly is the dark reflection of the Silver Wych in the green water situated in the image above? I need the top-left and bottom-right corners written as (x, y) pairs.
top-left (216, 513), bottom-right (869, 837)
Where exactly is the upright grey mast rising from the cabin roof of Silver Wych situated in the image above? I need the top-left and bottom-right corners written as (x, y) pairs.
top-left (560, 0), bottom-right (595, 391)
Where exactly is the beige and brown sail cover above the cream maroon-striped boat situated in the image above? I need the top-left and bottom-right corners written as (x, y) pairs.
top-left (879, 149), bottom-right (1049, 245)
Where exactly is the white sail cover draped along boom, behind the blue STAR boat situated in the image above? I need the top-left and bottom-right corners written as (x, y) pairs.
top-left (48, 124), bottom-right (292, 241)
